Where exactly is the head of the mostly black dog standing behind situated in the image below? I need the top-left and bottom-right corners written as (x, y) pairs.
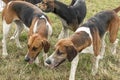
top-left (39, 0), bottom-right (55, 12)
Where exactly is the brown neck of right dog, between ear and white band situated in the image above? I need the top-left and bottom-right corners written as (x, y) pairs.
top-left (70, 31), bottom-right (92, 52)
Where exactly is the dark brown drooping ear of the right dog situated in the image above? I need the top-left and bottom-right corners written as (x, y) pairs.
top-left (65, 45), bottom-right (77, 62)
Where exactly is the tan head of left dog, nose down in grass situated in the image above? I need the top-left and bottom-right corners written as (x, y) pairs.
top-left (25, 34), bottom-right (50, 63)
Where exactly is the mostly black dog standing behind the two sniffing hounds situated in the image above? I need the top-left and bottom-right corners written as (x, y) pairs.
top-left (40, 0), bottom-right (86, 39)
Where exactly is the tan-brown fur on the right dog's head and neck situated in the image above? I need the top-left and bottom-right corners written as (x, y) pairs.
top-left (48, 31), bottom-right (92, 62)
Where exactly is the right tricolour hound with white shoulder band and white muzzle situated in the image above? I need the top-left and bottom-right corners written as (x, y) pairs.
top-left (46, 7), bottom-right (120, 80)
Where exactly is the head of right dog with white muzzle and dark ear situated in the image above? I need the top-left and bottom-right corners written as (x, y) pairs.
top-left (46, 39), bottom-right (77, 68)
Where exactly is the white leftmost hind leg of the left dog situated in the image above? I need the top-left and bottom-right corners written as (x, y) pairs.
top-left (2, 20), bottom-right (11, 57)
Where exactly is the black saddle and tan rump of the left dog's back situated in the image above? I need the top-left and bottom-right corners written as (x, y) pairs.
top-left (3, 1), bottom-right (43, 27)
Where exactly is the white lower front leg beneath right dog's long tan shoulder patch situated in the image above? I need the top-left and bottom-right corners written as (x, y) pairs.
top-left (92, 55), bottom-right (101, 76)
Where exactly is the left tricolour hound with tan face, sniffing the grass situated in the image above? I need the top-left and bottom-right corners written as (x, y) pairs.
top-left (2, 1), bottom-right (52, 62)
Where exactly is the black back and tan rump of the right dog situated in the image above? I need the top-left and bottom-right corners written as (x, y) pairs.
top-left (81, 7), bottom-right (120, 37)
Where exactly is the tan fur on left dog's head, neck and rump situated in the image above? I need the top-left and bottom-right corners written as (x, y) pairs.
top-left (2, 1), bottom-right (51, 60)
